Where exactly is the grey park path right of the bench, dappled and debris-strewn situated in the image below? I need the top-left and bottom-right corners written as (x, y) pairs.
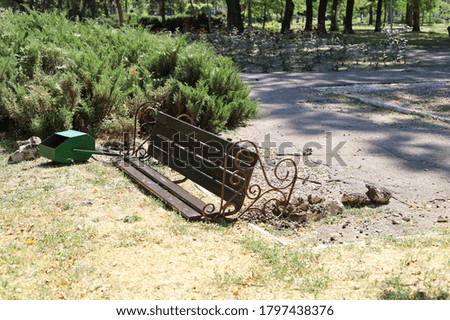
top-left (235, 70), bottom-right (450, 242)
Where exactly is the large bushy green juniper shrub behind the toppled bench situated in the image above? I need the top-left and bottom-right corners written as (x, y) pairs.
top-left (0, 11), bottom-right (256, 137)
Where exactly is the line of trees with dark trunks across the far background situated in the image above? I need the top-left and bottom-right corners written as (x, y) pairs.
top-left (0, 0), bottom-right (450, 33)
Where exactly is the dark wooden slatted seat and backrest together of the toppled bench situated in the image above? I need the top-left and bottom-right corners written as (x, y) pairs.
top-left (114, 108), bottom-right (259, 220)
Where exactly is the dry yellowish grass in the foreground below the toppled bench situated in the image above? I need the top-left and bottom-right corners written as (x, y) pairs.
top-left (0, 144), bottom-right (450, 299)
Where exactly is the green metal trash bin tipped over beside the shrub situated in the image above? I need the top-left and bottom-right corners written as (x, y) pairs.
top-left (39, 130), bottom-right (95, 164)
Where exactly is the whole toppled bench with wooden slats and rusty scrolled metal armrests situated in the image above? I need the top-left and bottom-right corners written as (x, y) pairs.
top-left (115, 102), bottom-right (298, 220)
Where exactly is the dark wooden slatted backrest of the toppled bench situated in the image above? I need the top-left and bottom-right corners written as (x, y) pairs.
top-left (148, 112), bottom-right (258, 212)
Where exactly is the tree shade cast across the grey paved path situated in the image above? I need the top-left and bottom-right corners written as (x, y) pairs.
top-left (244, 72), bottom-right (450, 177)
